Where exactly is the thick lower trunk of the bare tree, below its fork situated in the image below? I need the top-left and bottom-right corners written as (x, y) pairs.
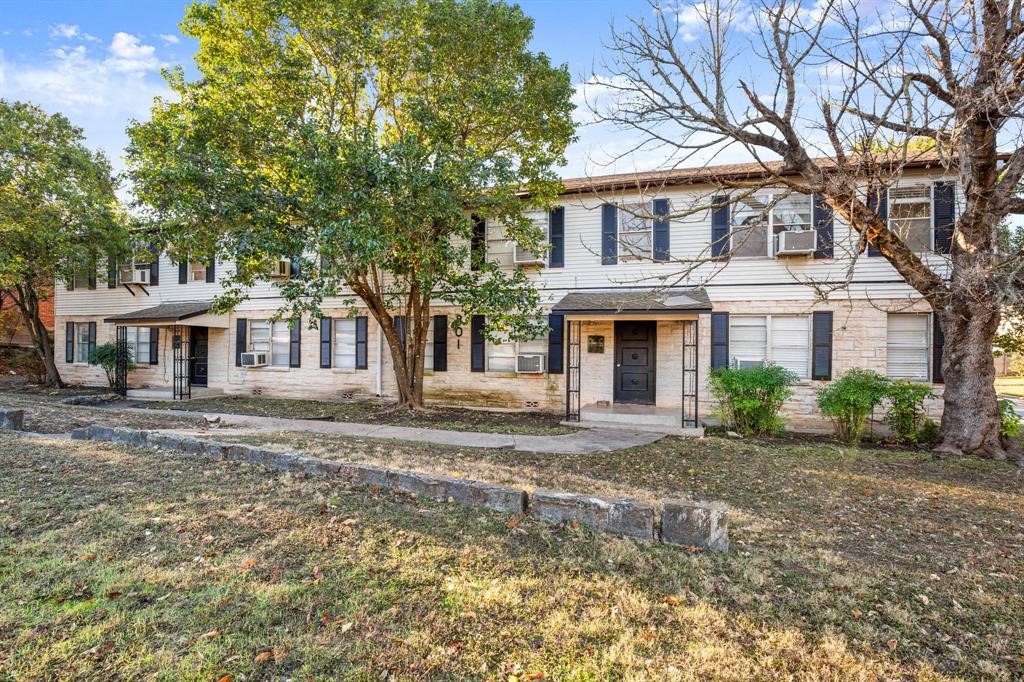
top-left (936, 297), bottom-right (1007, 460)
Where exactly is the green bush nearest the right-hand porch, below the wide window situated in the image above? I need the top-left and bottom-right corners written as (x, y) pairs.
top-left (709, 365), bottom-right (797, 435)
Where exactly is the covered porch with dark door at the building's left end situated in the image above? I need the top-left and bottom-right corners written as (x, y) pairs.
top-left (103, 301), bottom-right (228, 400)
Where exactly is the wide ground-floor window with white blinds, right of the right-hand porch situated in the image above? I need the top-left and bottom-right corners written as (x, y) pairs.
top-left (729, 315), bottom-right (811, 379)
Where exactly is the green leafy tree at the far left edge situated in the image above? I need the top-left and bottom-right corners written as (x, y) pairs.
top-left (0, 99), bottom-right (129, 386)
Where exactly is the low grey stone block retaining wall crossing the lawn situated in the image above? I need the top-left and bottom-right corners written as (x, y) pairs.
top-left (71, 425), bottom-right (729, 552)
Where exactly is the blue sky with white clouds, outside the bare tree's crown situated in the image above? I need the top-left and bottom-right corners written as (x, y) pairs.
top-left (0, 0), bottom-right (667, 176)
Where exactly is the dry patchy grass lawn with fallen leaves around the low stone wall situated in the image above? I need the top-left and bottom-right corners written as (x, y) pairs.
top-left (0, 435), bottom-right (1024, 682)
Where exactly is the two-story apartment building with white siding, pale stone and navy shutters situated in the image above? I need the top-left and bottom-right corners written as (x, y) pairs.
top-left (56, 158), bottom-right (959, 428)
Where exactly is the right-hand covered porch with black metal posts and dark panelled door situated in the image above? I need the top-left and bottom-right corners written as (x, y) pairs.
top-left (552, 289), bottom-right (711, 432)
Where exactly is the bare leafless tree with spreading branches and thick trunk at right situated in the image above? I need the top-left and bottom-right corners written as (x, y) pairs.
top-left (595, 0), bottom-right (1024, 459)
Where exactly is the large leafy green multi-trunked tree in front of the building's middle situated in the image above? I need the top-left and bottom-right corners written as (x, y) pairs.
top-left (128, 0), bottom-right (573, 408)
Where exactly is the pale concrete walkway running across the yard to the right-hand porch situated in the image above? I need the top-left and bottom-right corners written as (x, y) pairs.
top-left (115, 408), bottom-right (665, 455)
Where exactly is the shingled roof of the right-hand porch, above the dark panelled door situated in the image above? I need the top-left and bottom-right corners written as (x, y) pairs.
top-left (551, 289), bottom-right (712, 315)
